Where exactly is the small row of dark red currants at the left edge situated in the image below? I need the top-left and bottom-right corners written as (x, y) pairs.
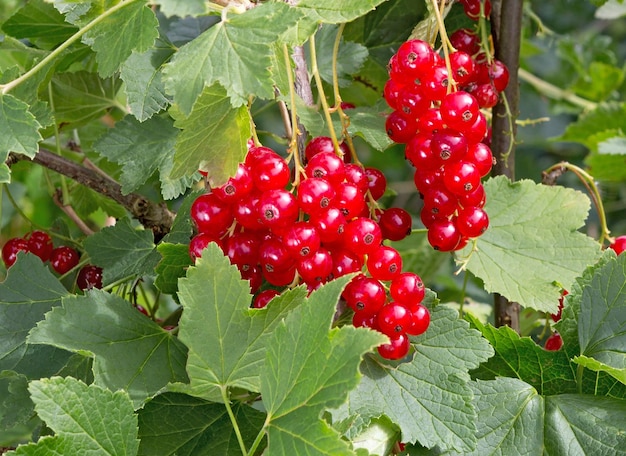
top-left (2, 230), bottom-right (102, 290)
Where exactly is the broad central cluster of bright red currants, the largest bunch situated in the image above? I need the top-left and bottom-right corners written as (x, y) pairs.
top-left (189, 137), bottom-right (428, 357)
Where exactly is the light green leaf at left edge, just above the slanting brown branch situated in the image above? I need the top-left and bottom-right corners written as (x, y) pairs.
top-left (0, 94), bottom-right (43, 182)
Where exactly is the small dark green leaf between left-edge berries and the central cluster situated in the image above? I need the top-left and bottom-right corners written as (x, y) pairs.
top-left (85, 219), bottom-right (160, 284)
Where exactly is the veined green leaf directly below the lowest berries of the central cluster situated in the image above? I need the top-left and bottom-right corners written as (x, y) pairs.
top-left (333, 306), bottom-right (493, 451)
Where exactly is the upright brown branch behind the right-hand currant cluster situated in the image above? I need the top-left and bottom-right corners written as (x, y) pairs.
top-left (491, 0), bottom-right (524, 332)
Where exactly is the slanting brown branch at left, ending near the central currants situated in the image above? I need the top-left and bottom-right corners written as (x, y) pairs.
top-left (6, 149), bottom-right (175, 242)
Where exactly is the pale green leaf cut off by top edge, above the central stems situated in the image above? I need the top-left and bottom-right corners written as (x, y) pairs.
top-left (296, 0), bottom-right (386, 24)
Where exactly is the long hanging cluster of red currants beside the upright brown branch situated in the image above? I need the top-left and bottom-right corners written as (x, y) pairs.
top-left (384, 30), bottom-right (509, 251)
